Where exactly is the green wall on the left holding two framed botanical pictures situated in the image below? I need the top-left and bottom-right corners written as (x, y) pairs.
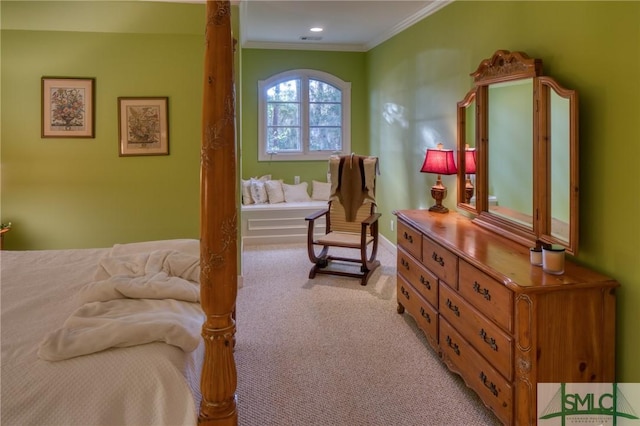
top-left (1, 1), bottom-right (205, 249)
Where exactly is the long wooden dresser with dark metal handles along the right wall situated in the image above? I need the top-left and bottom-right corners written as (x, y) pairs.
top-left (394, 210), bottom-right (619, 425)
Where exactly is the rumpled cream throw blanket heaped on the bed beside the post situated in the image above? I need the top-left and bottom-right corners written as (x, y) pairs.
top-left (38, 250), bottom-right (204, 361)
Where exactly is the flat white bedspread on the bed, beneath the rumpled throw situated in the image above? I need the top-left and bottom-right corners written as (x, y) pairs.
top-left (0, 240), bottom-right (204, 425)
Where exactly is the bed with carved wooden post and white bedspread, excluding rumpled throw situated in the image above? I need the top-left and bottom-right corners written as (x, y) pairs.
top-left (0, 1), bottom-right (238, 425)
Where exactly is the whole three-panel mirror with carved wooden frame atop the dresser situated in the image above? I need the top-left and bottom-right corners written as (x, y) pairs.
top-left (457, 50), bottom-right (578, 255)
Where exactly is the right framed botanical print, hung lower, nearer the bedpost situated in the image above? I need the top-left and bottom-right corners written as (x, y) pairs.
top-left (118, 96), bottom-right (169, 157)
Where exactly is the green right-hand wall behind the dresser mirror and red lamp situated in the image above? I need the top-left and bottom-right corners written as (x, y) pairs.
top-left (367, 1), bottom-right (640, 382)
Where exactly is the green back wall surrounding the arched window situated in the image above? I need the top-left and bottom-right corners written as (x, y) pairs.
top-left (241, 49), bottom-right (369, 185)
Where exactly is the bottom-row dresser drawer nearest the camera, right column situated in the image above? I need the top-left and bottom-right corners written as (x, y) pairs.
top-left (439, 318), bottom-right (513, 424)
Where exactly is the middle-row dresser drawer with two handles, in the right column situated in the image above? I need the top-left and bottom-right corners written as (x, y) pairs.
top-left (439, 284), bottom-right (513, 380)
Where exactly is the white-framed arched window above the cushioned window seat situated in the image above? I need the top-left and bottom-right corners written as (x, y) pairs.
top-left (258, 69), bottom-right (351, 161)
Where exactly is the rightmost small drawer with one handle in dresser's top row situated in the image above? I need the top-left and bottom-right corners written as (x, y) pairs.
top-left (458, 260), bottom-right (513, 332)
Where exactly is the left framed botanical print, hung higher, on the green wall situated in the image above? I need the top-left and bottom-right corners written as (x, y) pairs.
top-left (41, 77), bottom-right (95, 138)
